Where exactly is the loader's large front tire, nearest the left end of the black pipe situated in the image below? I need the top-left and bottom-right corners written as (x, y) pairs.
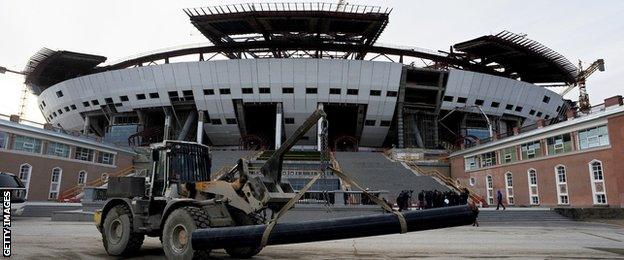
top-left (162, 206), bottom-right (210, 260)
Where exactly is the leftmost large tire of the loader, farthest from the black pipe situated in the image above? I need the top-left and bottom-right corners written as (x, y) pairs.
top-left (102, 204), bottom-right (145, 256)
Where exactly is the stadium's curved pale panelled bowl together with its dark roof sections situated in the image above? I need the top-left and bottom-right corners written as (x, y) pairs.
top-left (26, 3), bottom-right (578, 150)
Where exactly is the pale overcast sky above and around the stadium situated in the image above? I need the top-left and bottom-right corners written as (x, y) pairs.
top-left (0, 0), bottom-right (624, 122)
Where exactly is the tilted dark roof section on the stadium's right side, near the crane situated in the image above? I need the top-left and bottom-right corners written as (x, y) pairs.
top-left (453, 31), bottom-right (579, 83)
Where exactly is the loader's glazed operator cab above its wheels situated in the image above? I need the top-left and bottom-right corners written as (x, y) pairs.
top-left (149, 140), bottom-right (211, 198)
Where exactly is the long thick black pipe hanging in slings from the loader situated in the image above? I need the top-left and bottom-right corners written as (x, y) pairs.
top-left (191, 205), bottom-right (478, 250)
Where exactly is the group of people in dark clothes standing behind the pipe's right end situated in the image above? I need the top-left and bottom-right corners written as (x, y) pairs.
top-left (396, 189), bottom-right (469, 211)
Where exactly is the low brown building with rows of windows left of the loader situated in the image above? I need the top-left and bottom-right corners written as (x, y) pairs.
top-left (0, 117), bottom-right (134, 201)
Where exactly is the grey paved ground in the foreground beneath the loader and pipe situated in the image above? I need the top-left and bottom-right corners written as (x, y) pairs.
top-left (12, 218), bottom-right (624, 259)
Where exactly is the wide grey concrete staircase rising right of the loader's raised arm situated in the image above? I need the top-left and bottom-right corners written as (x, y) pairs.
top-left (335, 152), bottom-right (449, 203)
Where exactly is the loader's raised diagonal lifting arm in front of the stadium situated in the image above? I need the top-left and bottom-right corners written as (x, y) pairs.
top-left (260, 109), bottom-right (326, 185)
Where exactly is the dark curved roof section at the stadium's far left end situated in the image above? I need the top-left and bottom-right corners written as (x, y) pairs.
top-left (24, 48), bottom-right (106, 95)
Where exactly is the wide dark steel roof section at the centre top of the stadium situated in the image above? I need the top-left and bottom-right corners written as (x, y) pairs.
top-left (184, 2), bottom-right (391, 45)
